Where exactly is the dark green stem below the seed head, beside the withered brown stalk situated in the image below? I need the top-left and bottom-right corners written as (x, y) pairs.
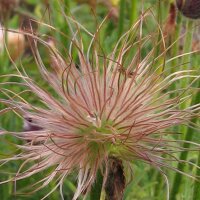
top-left (90, 170), bottom-right (103, 200)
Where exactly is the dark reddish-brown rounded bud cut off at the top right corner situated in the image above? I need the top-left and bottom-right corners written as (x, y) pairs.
top-left (176, 0), bottom-right (200, 19)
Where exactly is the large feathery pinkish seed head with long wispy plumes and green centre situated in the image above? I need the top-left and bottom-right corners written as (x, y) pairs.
top-left (1, 11), bottom-right (200, 199)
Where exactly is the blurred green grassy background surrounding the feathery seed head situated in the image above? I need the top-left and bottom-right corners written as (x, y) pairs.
top-left (0, 0), bottom-right (200, 200)
